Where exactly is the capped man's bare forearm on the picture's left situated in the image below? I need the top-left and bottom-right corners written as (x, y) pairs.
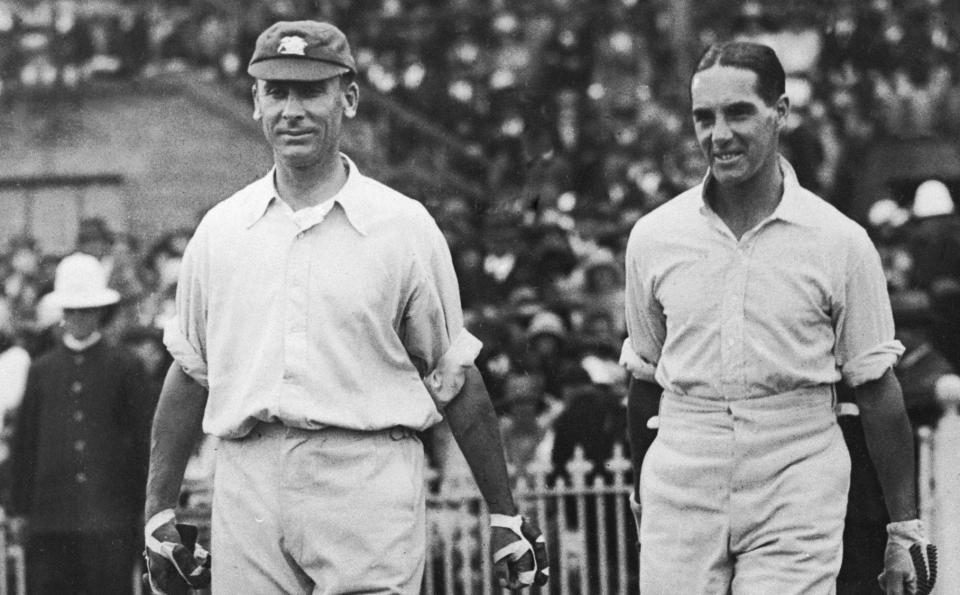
top-left (144, 363), bottom-right (207, 519)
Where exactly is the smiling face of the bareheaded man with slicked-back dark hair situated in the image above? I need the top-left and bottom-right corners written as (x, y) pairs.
top-left (690, 66), bottom-right (788, 185)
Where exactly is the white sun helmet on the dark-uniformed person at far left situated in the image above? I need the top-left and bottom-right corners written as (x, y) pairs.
top-left (50, 252), bottom-right (120, 310)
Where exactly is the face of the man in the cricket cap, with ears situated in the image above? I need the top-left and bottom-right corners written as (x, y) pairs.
top-left (253, 77), bottom-right (359, 167)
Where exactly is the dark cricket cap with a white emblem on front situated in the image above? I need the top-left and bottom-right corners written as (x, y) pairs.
top-left (247, 21), bottom-right (357, 81)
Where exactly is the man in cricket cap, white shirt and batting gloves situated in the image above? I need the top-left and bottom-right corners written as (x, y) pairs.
top-left (145, 21), bottom-right (548, 594)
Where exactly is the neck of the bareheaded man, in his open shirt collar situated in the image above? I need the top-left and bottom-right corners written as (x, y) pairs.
top-left (708, 162), bottom-right (783, 240)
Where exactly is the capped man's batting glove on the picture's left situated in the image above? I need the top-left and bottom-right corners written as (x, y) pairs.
top-left (143, 509), bottom-right (210, 595)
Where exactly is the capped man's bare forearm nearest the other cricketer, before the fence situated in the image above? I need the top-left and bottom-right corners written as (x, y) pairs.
top-left (444, 367), bottom-right (517, 515)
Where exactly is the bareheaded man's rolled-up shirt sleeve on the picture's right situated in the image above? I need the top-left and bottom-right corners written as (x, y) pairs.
top-left (834, 233), bottom-right (904, 386)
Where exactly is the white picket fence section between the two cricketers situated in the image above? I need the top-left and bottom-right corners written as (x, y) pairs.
top-left (423, 445), bottom-right (639, 595)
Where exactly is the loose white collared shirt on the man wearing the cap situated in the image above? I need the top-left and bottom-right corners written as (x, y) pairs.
top-left (164, 156), bottom-right (480, 438)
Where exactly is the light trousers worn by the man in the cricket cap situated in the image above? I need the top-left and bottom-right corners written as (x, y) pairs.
top-left (211, 423), bottom-right (426, 595)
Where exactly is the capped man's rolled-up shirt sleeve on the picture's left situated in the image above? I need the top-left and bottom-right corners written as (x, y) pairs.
top-left (163, 229), bottom-right (209, 388)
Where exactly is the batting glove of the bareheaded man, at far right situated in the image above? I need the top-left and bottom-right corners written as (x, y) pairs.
top-left (877, 520), bottom-right (937, 595)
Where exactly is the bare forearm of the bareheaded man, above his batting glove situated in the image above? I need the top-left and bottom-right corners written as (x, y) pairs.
top-left (854, 370), bottom-right (917, 521)
